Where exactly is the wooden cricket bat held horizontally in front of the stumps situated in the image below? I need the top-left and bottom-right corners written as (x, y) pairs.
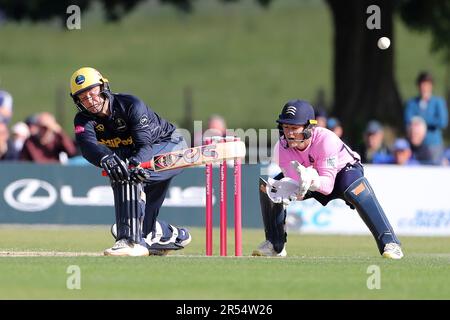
top-left (102, 141), bottom-right (246, 176)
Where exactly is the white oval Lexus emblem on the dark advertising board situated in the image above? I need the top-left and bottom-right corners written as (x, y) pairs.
top-left (4, 179), bottom-right (58, 212)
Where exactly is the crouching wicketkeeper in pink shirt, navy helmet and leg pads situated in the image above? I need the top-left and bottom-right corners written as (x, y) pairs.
top-left (253, 100), bottom-right (403, 259)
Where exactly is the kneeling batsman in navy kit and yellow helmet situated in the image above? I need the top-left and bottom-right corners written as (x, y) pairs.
top-left (70, 67), bottom-right (191, 256)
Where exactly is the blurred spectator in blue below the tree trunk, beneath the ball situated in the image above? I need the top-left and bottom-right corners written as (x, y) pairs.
top-left (358, 120), bottom-right (392, 164)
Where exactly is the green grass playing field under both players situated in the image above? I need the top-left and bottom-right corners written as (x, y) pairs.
top-left (0, 226), bottom-right (450, 300)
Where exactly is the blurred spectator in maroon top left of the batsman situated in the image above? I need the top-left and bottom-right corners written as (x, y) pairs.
top-left (20, 112), bottom-right (77, 163)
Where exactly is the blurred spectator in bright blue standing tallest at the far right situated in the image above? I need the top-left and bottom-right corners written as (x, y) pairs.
top-left (405, 72), bottom-right (448, 163)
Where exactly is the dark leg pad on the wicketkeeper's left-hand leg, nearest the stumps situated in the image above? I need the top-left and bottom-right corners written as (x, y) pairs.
top-left (259, 178), bottom-right (287, 253)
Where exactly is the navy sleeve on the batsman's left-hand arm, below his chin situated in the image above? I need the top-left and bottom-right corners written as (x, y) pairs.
top-left (74, 118), bottom-right (113, 167)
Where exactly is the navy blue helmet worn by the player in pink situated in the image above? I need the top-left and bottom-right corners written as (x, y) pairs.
top-left (277, 100), bottom-right (317, 125)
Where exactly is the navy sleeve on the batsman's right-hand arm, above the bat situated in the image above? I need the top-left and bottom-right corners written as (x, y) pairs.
top-left (128, 100), bottom-right (161, 162)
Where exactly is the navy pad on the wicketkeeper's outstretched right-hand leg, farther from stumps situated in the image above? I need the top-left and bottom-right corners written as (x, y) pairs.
top-left (344, 177), bottom-right (400, 254)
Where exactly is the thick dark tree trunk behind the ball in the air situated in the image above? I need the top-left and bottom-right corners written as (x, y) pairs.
top-left (326, 0), bottom-right (403, 142)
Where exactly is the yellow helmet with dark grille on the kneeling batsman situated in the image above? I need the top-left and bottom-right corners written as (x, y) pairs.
top-left (70, 67), bottom-right (111, 111)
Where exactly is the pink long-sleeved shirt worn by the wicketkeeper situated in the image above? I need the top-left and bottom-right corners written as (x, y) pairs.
top-left (272, 127), bottom-right (361, 195)
